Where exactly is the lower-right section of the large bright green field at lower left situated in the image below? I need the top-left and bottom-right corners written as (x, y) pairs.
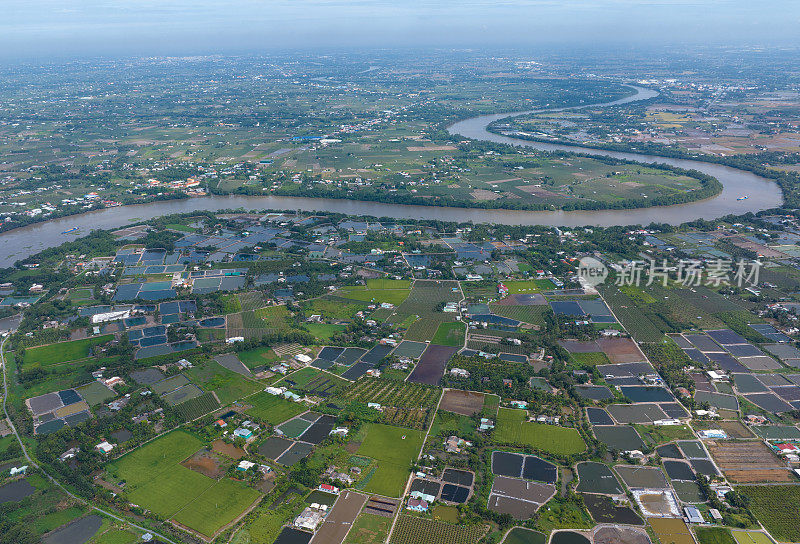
top-left (174, 478), bottom-right (260, 536)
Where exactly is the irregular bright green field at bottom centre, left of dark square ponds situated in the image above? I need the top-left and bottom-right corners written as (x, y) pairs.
top-left (358, 423), bottom-right (425, 497)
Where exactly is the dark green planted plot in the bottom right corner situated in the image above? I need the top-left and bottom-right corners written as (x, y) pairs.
top-left (737, 485), bottom-right (800, 542)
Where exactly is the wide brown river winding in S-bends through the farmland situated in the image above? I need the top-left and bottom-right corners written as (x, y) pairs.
top-left (0, 83), bottom-right (783, 267)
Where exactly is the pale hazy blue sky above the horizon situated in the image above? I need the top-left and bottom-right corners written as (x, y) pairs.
top-left (0, 0), bottom-right (800, 58)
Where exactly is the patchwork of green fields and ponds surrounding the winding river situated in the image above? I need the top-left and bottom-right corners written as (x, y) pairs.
top-left (0, 49), bottom-right (800, 544)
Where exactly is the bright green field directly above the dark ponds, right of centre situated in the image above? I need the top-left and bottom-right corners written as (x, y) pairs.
top-left (494, 408), bottom-right (586, 455)
